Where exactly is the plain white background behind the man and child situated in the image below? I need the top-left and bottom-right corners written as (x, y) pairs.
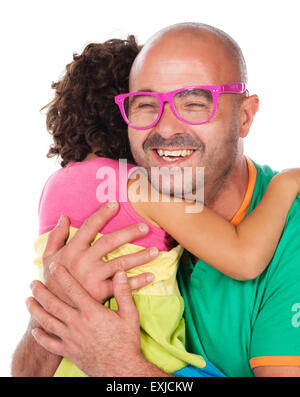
top-left (0, 0), bottom-right (300, 376)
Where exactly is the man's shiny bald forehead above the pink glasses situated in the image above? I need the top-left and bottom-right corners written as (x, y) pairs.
top-left (130, 25), bottom-right (244, 91)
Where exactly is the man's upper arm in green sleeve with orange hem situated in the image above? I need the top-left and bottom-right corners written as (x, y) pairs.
top-left (249, 203), bottom-right (300, 377)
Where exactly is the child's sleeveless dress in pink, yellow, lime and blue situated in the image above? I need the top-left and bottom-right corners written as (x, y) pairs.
top-left (35, 158), bottom-right (224, 377)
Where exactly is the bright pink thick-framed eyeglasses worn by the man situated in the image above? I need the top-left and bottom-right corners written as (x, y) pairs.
top-left (115, 83), bottom-right (246, 130)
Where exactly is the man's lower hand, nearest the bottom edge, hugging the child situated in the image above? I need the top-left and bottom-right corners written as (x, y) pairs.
top-left (27, 263), bottom-right (167, 377)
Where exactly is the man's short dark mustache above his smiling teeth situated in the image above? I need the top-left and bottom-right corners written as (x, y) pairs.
top-left (143, 133), bottom-right (205, 152)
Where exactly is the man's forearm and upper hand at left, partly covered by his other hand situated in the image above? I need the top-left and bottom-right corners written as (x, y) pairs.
top-left (11, 205), bottom-right (158, 377)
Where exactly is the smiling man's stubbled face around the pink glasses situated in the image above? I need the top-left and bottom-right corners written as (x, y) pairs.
top-left (128, 31), bottom-right (244, 201)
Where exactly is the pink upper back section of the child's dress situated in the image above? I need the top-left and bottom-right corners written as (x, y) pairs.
top-left (39, 157), bottom-right (170, 251)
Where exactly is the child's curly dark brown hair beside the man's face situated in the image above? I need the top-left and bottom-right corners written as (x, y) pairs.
top-left (42, 35), bottom-right (141, 167)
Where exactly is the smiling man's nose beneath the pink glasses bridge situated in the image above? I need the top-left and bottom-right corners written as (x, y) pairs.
top-left (154, 103), bottom-right (185, 138)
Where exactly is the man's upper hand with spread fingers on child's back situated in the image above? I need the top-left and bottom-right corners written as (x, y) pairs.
top-left (43, 203), bottom-right (158, 302)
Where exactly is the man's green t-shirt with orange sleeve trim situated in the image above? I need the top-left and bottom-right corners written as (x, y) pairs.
top-left (178, 162), bottom-right (300, 376)
